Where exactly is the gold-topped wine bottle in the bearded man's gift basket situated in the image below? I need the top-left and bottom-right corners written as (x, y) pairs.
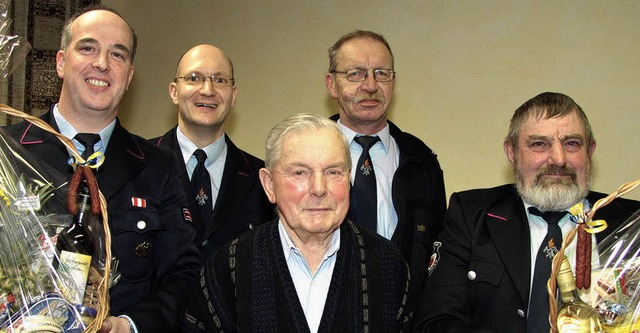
top-left (557, 256), bottom-right (604, 333)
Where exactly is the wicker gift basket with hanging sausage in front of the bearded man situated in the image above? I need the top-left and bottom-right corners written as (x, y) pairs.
top-left (547, 180), bottom-right (640, 333)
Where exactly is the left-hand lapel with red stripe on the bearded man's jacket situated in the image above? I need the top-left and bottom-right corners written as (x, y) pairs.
top-left (486, 197), bottom-right (531, 304)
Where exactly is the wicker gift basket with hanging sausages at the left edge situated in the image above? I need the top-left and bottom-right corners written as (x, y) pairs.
top-left (0, 104), bottom-right (113, 333)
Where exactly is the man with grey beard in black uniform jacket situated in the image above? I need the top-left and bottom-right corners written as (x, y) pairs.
top-left (416, 92), bottom-right (640, 333)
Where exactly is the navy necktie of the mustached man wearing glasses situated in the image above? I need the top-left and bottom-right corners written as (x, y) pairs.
top-left (351, 136), bottom-right (380, 231)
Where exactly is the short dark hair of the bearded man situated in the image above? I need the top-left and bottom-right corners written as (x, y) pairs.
top-left (505, 92), bottom-right (595, 149)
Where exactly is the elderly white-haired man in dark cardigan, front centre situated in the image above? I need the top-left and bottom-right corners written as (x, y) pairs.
top-left (185, 114), bottom-right (412, 332)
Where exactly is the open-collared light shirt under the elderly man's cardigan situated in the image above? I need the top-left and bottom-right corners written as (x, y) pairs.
top-left (278, 221), bottom-right (340, 333)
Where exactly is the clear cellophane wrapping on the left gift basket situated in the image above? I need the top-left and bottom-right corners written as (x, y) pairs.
top-left (0, 128), bottom-right (96, 332)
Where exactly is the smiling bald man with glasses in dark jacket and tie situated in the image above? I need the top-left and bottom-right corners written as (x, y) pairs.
top-left (150, 44), bottom-right (275, 263)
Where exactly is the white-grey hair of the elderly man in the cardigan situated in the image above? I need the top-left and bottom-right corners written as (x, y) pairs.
top-left (264, 113), bottom-right (351, 170)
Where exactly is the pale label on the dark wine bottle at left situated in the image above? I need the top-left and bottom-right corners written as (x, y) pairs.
top-left (60, 251), bottom-right (91, 304)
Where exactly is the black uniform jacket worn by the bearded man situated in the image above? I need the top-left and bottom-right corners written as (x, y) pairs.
top-left (415, 184), bottom-right (640, 333)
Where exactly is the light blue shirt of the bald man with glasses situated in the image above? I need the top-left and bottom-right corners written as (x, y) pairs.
top-left (176, 127), bottom-right (227, 208)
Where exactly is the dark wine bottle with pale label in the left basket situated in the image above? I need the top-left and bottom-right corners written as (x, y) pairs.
top-left (56, 181), bottom-right (95, 304)
